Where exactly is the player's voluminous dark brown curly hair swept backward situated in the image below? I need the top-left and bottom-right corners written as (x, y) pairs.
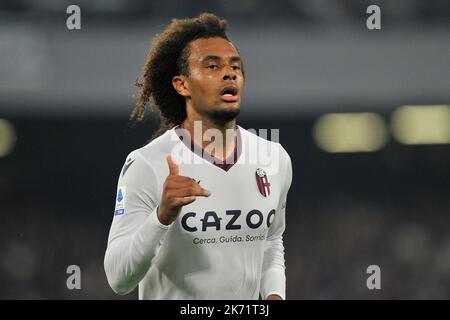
top-left (130, 13), bottom-right (229, 140)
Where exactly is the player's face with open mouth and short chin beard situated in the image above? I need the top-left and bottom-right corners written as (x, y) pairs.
top-left (182, 37), bottom-right (244, 120)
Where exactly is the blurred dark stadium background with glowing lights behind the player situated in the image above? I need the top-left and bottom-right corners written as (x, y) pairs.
top-left (0, 0), bottom-right (450, 299)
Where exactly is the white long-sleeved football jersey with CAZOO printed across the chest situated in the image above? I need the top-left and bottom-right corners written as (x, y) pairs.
top-left (104, 126), bottom-right (292, 299)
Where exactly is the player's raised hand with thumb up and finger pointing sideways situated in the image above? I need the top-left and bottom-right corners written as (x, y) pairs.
top-left (157, 156), bottom-right (211, 225)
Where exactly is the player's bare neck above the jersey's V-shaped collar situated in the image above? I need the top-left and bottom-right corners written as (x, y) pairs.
top-left (182, 109), bottom-right (237, 159)
